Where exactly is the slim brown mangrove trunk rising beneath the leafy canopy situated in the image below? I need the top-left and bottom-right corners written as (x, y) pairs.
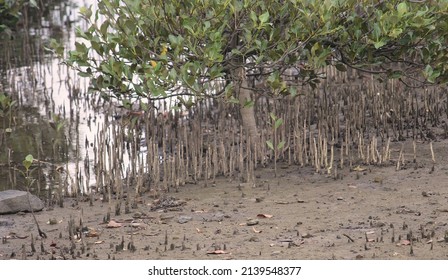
top-left (234, 67), bottom-right (258, 140)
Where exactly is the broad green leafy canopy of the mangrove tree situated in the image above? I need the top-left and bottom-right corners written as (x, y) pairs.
top-left (53, 0), bottom-right (448, 102)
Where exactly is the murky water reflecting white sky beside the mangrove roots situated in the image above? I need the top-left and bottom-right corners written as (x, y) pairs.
top-left (0, 0), bottom-right (100, 195)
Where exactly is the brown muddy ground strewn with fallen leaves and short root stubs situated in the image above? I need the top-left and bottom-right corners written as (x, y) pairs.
top-left (0, 140), bottom-right (448, 260)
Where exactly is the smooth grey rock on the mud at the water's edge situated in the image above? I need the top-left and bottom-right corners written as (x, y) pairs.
top-left (0, 190), bottom-right (44, 214)
